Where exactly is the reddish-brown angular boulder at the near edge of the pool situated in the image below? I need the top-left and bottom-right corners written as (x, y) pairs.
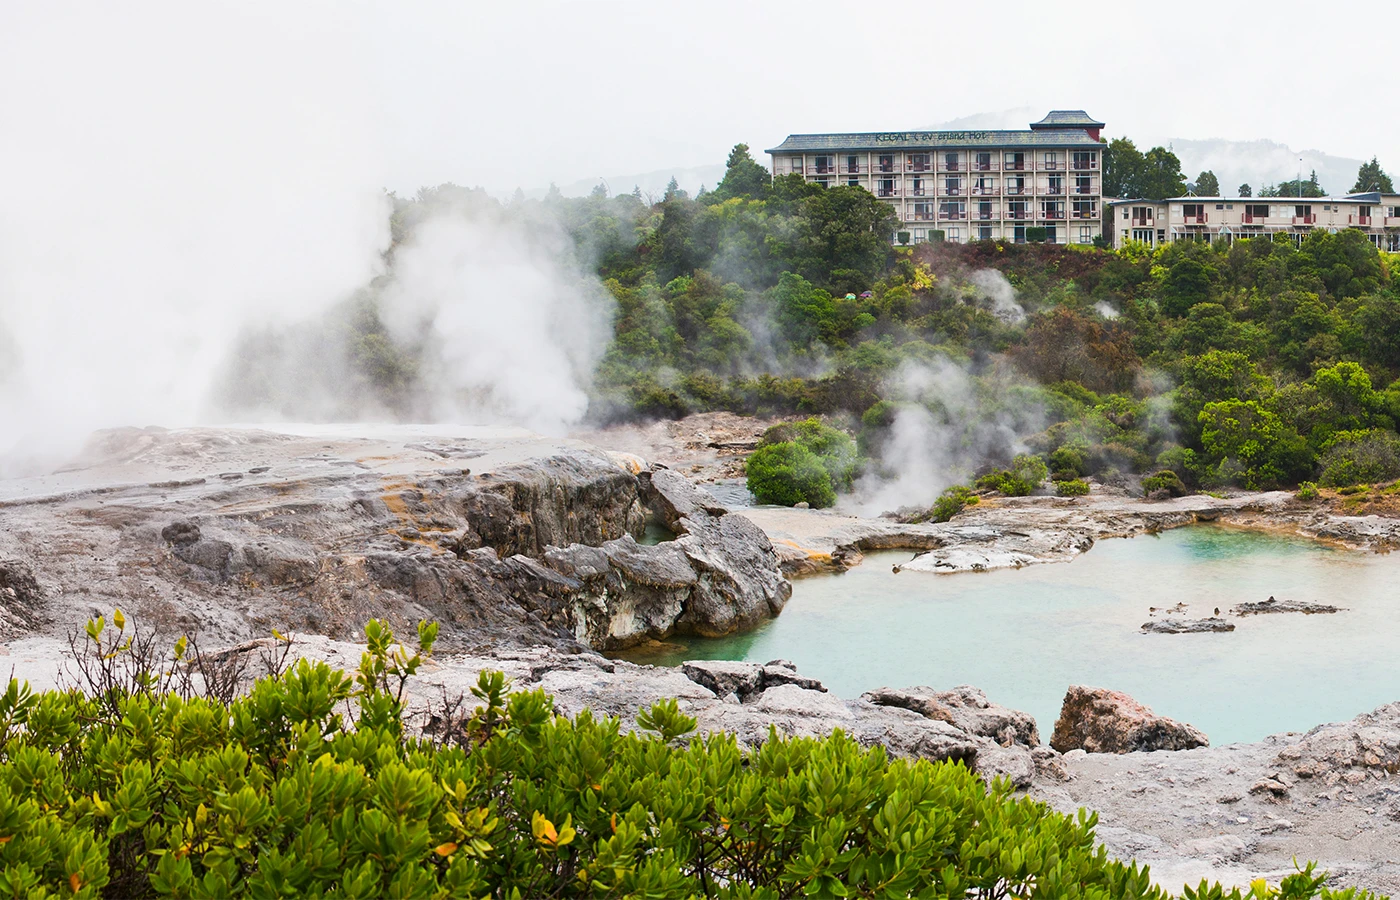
top-left (1050, 684), bottom-right (1210, 753)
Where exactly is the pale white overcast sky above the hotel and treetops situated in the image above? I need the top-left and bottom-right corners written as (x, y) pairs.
top-left (0, 0), bottom-right (1400, 190)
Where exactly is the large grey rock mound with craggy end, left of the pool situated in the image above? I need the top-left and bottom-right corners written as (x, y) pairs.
top-left (0, 427), bottom-right (791, 651)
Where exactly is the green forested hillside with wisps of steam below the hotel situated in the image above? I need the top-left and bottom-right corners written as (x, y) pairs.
top-left (371, 144), bottom-right (1400, 503)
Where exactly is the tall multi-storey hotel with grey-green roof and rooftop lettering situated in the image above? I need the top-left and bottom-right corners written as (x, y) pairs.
top-left (767, 109), bottom-right (1103, 244)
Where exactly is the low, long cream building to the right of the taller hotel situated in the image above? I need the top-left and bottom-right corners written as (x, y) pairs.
top-left (1105, 193), bottom-right (1400, 253)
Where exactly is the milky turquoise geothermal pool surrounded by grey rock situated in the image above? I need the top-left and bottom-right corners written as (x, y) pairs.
top-left (629, 525), bottom-right (1400, 746)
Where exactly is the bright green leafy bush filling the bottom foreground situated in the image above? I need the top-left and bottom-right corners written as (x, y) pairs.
top-left (0, 617), bottom-right (1383, 897)
